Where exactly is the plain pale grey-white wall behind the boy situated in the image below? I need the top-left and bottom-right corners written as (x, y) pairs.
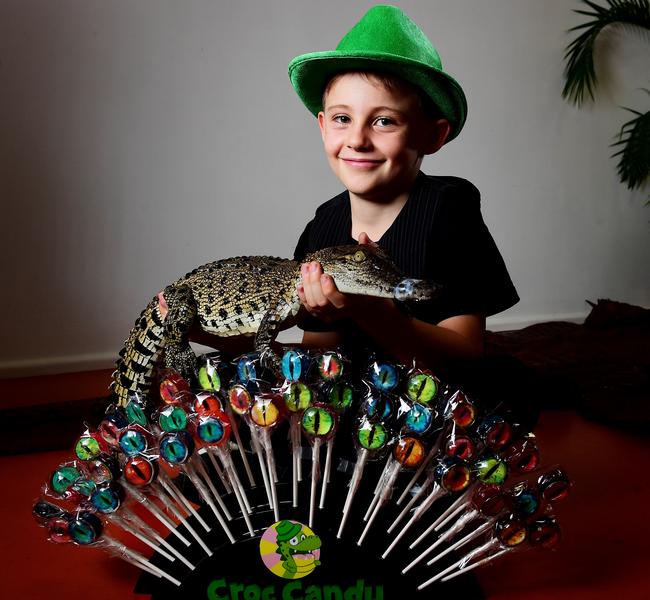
top-left (0, 0), bottom-right (650, 375)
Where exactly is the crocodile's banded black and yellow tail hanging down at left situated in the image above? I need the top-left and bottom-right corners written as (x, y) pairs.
top-left (110, 297), bottom-right (165, 406)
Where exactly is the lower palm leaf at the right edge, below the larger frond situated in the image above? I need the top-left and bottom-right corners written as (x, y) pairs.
top-left (612, 102), bottom-right (650, 190)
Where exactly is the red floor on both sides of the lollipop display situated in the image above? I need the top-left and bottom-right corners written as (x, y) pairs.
top-left (5, 404), bottom-right (650, 600)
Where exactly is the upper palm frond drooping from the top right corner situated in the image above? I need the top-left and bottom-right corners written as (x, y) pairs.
top-left (562, 0), bottom-right (650, 106)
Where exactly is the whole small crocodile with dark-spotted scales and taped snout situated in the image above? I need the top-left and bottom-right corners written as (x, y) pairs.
top-left (111, 245), bottom-right (436, 406)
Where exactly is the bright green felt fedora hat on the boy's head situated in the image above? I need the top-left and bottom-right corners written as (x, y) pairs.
top-left (289, 5), bottom-right (467, 141)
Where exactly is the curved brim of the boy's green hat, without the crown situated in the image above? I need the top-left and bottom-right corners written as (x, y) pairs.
top-left (289, 50), bottom-right (467, 142)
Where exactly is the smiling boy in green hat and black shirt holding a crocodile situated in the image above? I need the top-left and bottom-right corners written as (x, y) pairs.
top-left (289, 6), bottom-right (518, 376)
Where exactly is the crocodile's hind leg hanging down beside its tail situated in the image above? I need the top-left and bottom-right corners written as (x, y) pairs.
top-left (163, 285), bottom-right (197, 384)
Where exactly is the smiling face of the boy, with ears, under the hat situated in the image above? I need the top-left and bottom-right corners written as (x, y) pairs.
top-left (318, 73), bottom-right (449, 202)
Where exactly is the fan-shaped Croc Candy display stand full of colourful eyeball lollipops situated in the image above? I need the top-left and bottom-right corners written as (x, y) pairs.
top-left (33, 348), bottom-right (571, 600)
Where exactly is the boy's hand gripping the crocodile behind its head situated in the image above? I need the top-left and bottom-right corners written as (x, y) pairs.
top-left (298, 232), bottom-right (388, 323)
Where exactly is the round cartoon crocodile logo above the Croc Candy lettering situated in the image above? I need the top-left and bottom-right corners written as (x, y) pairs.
top-left (263, 520), bottom-right (321, 579)
